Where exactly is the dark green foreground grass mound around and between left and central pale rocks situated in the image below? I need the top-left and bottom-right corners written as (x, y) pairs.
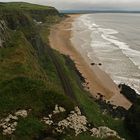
top-left (0, 77), bottom-right (75, 140)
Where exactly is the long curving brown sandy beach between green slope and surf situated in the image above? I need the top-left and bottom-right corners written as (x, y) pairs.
top-left (49, 15), bottom-right (131, 109)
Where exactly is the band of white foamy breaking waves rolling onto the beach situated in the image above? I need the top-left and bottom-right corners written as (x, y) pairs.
top-left (72, 14), bottom-right (140, 93)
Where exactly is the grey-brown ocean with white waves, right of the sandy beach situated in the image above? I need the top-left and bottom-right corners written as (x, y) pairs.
top-left (71, 13), bottom-right (140, 94)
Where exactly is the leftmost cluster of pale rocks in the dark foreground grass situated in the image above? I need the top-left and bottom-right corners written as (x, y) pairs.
top-left (0, 110), bottom-right (28, 135)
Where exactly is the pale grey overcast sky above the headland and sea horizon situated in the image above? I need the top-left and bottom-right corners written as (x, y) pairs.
top-left (0, 0), bottom-right (140, 10)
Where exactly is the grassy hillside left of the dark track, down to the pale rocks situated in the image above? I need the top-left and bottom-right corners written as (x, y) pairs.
top-left (0, 3), bottom-right (74, 140)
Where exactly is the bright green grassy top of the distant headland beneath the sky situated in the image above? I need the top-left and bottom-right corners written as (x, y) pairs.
top-left (0, 2), bottom-right (53, 10)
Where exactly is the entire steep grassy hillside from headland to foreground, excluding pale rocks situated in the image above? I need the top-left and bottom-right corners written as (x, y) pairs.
top-left (0, 3), bottom-right (135, 140)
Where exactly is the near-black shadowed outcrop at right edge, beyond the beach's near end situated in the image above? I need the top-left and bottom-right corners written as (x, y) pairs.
top-left (119, 84), bottom-right (140, 140)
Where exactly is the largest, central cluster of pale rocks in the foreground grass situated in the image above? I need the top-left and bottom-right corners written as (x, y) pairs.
top-left (42, 105), bottom-right (87, 135)
